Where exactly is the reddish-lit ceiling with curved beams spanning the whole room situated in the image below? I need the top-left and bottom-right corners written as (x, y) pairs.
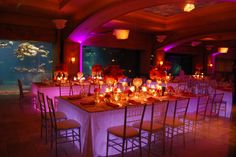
top-left (0, 0), bottom-right (236, 54)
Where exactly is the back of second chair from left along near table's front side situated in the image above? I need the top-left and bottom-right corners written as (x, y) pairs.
top-left (151, 101), bottom-right (169, 130)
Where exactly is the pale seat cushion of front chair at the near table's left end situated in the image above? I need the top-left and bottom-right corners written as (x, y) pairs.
top-left (57, 119), bottom-right (80, 130)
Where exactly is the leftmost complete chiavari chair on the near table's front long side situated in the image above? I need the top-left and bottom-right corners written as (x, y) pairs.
top-left (106, 105), bottom-right (146, 157)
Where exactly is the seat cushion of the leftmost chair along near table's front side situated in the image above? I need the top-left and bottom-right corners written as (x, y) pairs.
top-left (107, 125), bottom-right (139, 138)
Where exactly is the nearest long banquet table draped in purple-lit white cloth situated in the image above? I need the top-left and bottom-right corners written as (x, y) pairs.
top-left (56, 94), bottom-right (201, 157)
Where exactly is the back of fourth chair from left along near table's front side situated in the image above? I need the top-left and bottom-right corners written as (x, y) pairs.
top-left (196, 95), bottom-right (209, 120)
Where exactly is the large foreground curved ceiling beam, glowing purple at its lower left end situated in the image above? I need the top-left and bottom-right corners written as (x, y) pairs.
top-left (69, 0), bottom-right (188, 43)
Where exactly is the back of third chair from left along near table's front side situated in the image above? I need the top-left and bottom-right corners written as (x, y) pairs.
top-left (173, 98), bottom-right (189, 125)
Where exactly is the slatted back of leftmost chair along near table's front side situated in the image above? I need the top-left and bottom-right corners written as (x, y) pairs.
top-left (123, 104), bottom-right (146, 137)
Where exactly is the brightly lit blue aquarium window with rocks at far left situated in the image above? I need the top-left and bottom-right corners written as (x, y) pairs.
top-left (0, 40), bottom-right (53, 92)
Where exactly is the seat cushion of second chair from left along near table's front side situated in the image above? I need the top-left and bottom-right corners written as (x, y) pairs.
top-left (133, 121), bottom-right (163, 132)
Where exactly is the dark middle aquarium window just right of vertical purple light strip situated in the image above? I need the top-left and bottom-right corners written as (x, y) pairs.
top-left (82, 46), bottom-right (140, 77)
